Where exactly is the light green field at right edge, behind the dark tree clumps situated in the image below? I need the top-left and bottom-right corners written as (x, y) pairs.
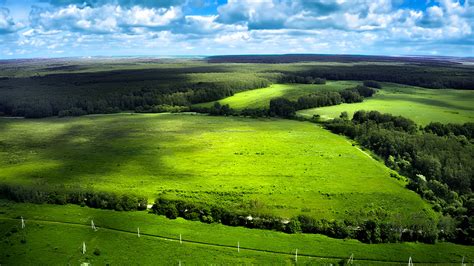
top-left (297, 83), bottom-right (474, 125)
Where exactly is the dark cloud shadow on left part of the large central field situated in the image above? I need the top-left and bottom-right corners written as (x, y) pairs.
top-left (1, 114), bottom-right (203, 191)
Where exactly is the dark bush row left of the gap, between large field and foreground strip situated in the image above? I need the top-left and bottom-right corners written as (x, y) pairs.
top-left (0, 184), bottom-right (148, 211)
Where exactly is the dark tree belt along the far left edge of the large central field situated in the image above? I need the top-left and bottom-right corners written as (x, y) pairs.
top-left (0, 80), bottom-right (269, 118)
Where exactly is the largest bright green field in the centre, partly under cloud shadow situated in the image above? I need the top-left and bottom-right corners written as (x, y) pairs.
top-left (0, 114), bottom-right (434, 224)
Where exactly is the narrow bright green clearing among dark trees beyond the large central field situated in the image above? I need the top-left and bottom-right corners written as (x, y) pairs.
top-left (196, 81), bottom-right (361, 110)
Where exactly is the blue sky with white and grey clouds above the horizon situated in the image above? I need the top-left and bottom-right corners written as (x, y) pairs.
top-left (0, 0), bottom-right (474, 58)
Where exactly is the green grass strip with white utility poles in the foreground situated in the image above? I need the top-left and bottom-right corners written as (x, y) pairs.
top-left (0, 201), bottom-right (474, 265)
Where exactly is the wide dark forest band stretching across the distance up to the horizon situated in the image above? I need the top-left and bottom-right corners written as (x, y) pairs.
top-left (0, 59), bottom-right (474, 118)
